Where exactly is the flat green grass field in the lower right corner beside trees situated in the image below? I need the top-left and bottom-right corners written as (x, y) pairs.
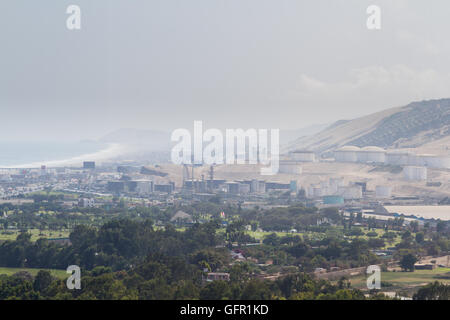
top-left (350, 268), bottom-right (450, 291)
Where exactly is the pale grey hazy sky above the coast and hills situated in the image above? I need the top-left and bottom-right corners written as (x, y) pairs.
top-left (0, 0), bottom-right (450, 141)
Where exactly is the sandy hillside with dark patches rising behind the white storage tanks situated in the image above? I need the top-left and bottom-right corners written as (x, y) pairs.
top-left (287, 99), bottom-right (450, 152)
